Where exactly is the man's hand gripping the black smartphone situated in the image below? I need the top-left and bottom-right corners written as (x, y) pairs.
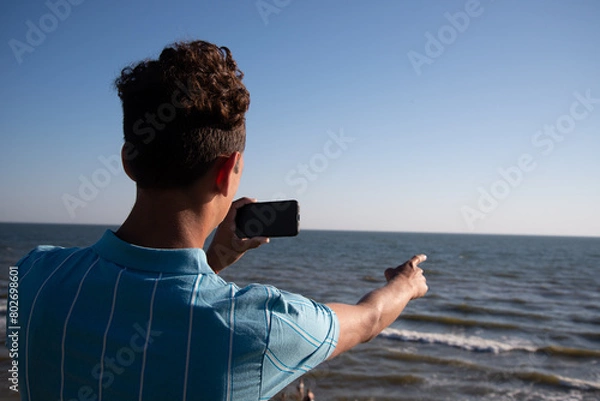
top-left (206, 198), bottom-right (269, 273)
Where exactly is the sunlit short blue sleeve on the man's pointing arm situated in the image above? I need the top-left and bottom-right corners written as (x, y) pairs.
top-left (261, 288), bottom-right (339, 400)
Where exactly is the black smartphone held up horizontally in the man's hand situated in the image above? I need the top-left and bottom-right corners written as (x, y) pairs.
top-left (235, 200), bottom-right (300, 238)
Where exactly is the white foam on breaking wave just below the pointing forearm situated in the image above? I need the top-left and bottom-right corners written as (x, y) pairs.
top-left (379, 328), bottom-right (537, 354)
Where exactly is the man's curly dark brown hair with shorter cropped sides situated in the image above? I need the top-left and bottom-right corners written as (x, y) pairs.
top-left (115, 40), bottom-right (250, 188)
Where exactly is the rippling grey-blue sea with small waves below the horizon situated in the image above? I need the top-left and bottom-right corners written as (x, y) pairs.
top-left (0, 224), bottom-right (600, 401)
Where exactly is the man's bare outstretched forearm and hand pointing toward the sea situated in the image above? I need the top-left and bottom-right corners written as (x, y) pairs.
top-left (327, 255), bottom-right (428, 359)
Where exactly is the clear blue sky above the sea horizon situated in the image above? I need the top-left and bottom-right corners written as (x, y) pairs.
top-left (0, 0), bottom-right (600, 236)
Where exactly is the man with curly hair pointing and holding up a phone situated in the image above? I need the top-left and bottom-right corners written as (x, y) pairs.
top-left (12, 41), bottom-right (427, 401)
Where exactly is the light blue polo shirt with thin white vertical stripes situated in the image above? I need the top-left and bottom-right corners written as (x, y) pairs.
top-left (12, 231), bottom-right (339, 401)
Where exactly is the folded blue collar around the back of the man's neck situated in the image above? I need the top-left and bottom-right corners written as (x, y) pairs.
top-left (93, 230), bottom-right (214, 274)
